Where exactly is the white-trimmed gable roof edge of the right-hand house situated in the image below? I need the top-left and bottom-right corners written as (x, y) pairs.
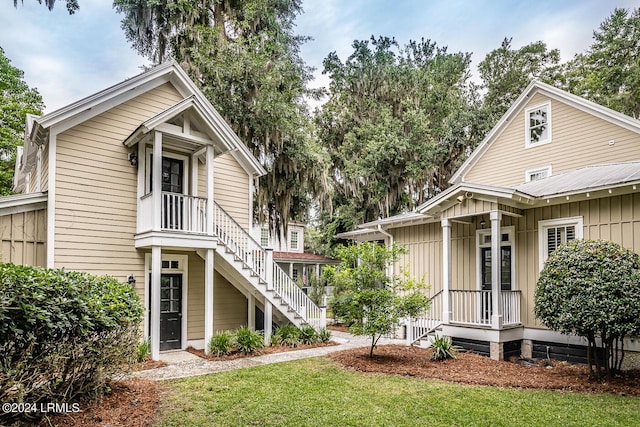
top-left (449, 80), bottom-right (640, 184)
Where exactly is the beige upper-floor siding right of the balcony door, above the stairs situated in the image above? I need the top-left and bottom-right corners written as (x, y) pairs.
top-left (198, 153), bottom-right (253, 233)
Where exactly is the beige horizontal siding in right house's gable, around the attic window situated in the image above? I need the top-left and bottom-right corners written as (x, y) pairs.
top-left (463, 94), bottom-right (640, 186)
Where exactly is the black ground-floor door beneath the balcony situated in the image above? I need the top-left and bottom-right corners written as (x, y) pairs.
top-left (160, 274), bottom-right (182, 351)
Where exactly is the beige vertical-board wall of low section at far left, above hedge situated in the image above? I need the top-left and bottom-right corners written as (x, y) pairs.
top-left (0, 209), bottom-right (47, 267)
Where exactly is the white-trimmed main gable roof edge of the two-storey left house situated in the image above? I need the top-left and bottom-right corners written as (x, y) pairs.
top-left (20, 61), bottom-right (266, 186)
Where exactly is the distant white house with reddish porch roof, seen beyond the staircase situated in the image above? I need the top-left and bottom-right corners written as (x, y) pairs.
top-left (253, 222), bottom-right (338, 289)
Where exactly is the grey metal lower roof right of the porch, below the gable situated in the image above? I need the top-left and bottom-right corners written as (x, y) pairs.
top-left (514, 162), bottom-right (640, 197)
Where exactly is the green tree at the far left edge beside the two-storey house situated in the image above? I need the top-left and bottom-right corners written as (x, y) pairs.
top-left (0, 47), bottom-right (44, 196)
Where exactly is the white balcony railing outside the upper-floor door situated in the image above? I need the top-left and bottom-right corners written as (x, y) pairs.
top-left (138, 191), bottom-right (207, 233)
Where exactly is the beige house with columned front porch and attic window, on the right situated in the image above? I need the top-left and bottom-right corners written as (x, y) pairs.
top-left (340, 82), bottom-right (640, 361)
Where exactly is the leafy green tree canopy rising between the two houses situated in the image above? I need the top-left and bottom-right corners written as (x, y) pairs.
top-left (316, 37), bottom-right (474, 234)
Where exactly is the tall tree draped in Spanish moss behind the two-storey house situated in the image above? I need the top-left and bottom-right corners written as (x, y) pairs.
top-left (114, 0), bottom-right (326, 234)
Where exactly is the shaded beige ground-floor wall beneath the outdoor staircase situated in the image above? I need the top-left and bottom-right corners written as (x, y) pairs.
top-left (187, 253), bottom-right (247, 340)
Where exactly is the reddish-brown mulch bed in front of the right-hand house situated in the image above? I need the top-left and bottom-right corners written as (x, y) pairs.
top-left (328, 345), bottom-right (640, 396)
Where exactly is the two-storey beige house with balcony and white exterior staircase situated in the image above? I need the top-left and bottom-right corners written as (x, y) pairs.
top-left (0, 63), bottom-right (325, 359)
